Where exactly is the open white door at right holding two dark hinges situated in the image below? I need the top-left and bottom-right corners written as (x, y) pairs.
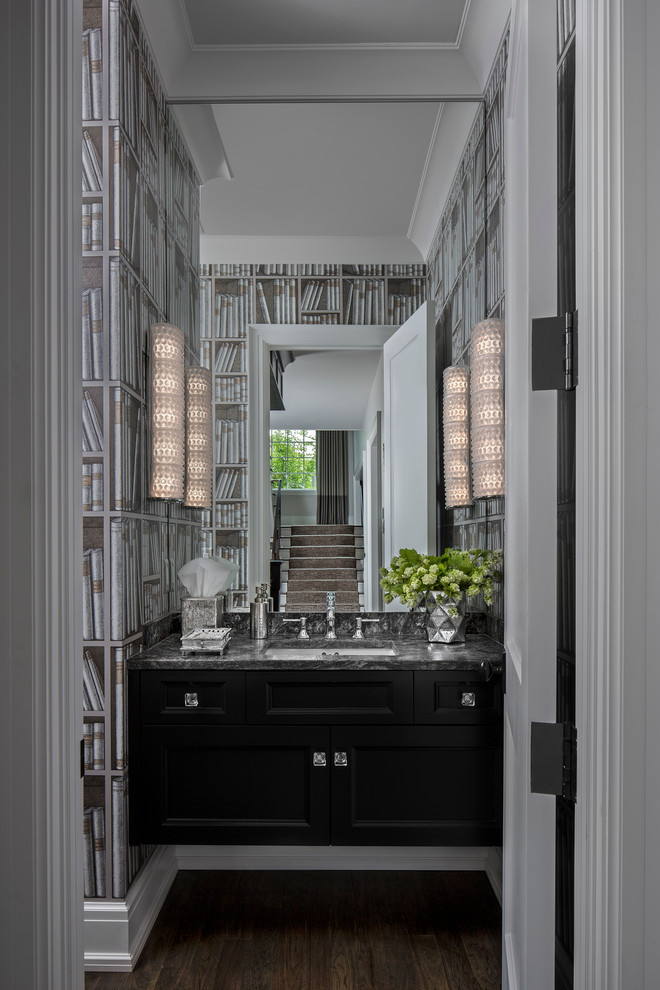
top-left (502, 0), bottom-right (557, 990)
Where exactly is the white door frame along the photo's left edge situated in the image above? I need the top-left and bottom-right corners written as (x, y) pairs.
top-left (0, 0), bottom-right (83, 990)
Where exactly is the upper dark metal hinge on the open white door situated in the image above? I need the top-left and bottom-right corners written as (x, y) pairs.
top-left (532, 310), bottom-right (578, 392)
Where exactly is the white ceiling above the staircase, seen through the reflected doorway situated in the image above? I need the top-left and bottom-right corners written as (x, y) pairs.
top-left (270, 350), bottom-right (382, 430)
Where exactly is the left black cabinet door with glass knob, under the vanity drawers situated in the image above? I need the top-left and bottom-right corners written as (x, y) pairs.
top-left (138, 725), bottom-right (330, 845)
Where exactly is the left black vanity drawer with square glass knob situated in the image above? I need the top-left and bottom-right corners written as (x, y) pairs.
top-left (139, 670), bottom-right (245, 725)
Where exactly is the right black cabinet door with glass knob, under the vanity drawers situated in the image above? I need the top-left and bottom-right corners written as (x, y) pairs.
top-left (330, 725), bottom-right (502, 846)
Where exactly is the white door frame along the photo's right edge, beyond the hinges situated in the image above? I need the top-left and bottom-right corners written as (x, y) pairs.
top-left (575, 0), bottom-right (660, 990)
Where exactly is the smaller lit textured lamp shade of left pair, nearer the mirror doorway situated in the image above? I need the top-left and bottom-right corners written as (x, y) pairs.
top-left (184, 368), bottom-right (213, 509)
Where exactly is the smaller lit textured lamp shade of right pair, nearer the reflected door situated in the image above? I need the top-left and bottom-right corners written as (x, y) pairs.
top-left (442, 365), bottom-right (472, 509)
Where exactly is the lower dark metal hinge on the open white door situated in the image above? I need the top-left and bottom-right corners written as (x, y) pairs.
top-left (530, 722), bottom-right (577, 804)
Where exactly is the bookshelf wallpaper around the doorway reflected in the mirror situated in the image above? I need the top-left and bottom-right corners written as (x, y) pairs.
top-left (200, 263), bottom-right (426, 608)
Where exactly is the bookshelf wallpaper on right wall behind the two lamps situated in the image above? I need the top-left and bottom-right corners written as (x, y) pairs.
top-left (427, 36), bottom-right (508, 641)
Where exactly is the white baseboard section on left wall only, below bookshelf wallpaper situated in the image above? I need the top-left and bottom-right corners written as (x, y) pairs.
top-left (84, 846), bottom-right (179, 972)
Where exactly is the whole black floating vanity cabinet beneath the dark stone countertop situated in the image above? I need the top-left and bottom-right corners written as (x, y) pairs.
top-left (129, 670), bottom-right (502, 845)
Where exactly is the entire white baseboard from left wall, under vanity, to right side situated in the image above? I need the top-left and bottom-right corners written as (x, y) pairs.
top-left (84, 846), bottom-right (502, 972)
